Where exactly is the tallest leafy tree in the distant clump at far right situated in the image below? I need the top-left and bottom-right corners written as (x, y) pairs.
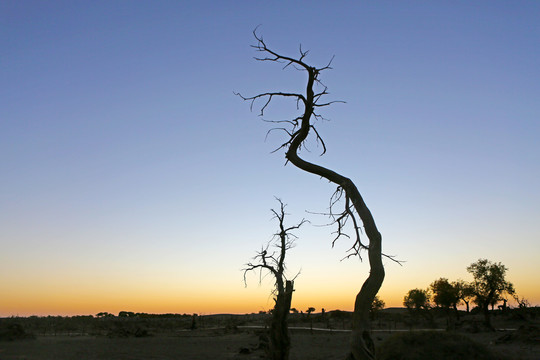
top-left (467, 259), bottom-right (514, 328)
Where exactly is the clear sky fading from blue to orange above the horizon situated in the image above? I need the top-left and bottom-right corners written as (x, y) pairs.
top-left (0, 0), bottom-right (540, 316)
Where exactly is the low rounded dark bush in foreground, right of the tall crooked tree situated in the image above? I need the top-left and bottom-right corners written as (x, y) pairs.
top-left (377, 331), bottom-right (501, 360)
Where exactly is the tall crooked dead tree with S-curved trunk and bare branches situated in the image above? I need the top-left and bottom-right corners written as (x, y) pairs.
top-left (237, 31), bottom-right (391, 360)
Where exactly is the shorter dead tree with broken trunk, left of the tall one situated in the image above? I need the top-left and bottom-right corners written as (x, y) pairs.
top-left (244, 199), bottom-right (306, 360)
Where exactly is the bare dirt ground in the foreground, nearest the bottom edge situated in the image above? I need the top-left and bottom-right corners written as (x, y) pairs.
top-left (0, 329), bottom-right (540, 360)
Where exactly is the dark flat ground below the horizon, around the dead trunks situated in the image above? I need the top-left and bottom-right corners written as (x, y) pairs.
top-left (0, 310), bottom-right (540, 360)
